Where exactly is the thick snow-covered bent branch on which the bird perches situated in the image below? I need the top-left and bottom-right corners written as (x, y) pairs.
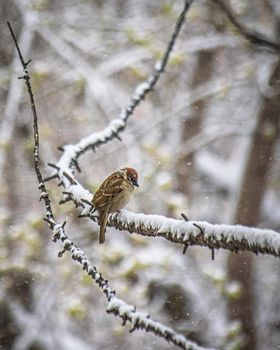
top-left (32, 0), bottom-right (280, 257)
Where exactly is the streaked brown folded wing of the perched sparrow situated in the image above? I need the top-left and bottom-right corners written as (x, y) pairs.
top-left (92, 173), bottom-right (123, 210)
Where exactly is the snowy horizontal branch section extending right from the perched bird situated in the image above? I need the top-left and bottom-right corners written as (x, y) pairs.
top-left (104, 210), bottom-right (280, 257)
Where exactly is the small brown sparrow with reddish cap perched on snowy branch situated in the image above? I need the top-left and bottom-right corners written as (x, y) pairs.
top-left (92, 167), bottom-right (139, 244)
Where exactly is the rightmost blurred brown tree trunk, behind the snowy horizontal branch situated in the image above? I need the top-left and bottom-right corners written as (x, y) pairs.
top-left (228, 58), bottom-right (280, 350)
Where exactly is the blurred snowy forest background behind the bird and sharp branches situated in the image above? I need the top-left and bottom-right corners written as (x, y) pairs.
top-left (0, 0), bottom-right (280, 350)
